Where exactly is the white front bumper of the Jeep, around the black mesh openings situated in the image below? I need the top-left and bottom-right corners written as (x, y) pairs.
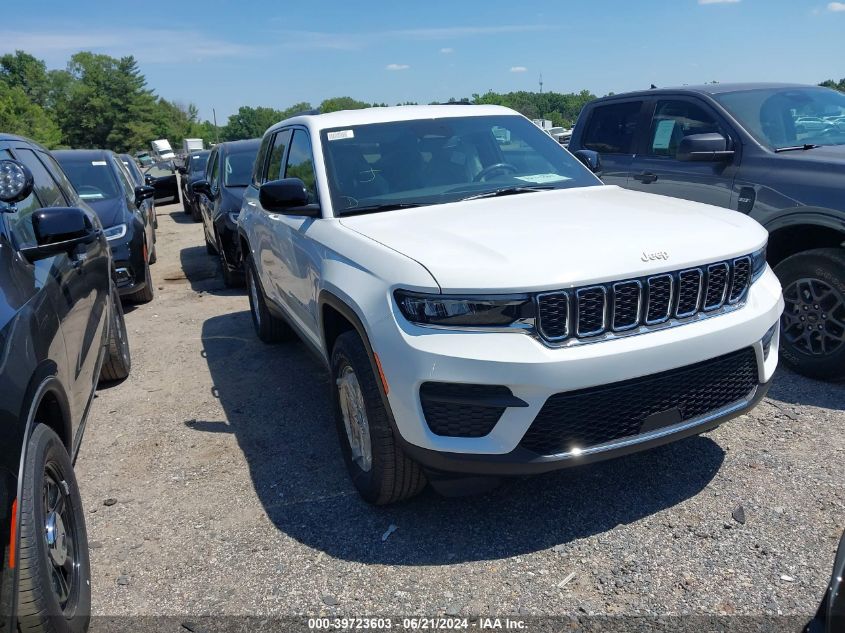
top-left (371, 269), bottom-right (783, 474)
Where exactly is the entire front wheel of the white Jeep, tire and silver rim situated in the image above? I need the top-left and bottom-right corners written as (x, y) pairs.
top-left (331, 331), bottom-right (426, 505)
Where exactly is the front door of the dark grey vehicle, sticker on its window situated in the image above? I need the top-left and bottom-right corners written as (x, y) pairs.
top-left (628, 96), bottom-right (739, 207)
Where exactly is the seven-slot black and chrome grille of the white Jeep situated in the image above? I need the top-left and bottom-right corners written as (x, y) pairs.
top-left (537, 257), bottom-right (751, 341)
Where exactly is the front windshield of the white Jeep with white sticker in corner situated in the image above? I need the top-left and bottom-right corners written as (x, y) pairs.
top-left (322, 115), bottom-right (601, 214)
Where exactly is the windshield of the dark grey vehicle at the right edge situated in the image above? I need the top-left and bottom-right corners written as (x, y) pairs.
top-left (714, 87), bottom-right (845, 149)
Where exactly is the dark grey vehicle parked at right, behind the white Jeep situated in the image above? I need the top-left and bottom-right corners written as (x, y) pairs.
top-left (569, 84), bottom-right (845, 379)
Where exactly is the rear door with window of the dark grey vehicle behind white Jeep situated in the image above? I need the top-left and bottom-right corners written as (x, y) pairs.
top-left (570, 99), bottom-right (645, 186)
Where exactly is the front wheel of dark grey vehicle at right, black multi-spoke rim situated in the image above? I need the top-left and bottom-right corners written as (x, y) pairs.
top-left (775, 248), bottom-right (845, 380)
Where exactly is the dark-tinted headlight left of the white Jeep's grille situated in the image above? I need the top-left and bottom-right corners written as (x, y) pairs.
top-left (394, 290), bottom-right (534, 327)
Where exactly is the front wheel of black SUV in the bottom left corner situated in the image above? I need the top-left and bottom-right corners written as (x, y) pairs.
top-left (17, 424), bottom-right (91, 633)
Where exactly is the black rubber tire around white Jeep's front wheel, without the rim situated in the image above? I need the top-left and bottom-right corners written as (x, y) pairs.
top-left (331, 331), bottom-right (426, 505)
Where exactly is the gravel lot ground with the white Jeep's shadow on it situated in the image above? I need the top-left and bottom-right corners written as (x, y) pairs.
top-left (77, 200), bottom-right (845, 618)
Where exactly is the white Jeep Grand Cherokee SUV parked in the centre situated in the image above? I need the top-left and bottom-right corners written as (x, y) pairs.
top-left (238, 105), bottom-right (783, 503)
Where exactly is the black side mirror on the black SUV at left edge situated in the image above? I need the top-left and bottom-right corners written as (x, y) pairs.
top-left (20, 207), bottom-right (100, 262)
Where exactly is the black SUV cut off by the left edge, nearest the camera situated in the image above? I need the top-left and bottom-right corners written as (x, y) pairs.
top-left (0, 134), bottom-right (130, 632)
